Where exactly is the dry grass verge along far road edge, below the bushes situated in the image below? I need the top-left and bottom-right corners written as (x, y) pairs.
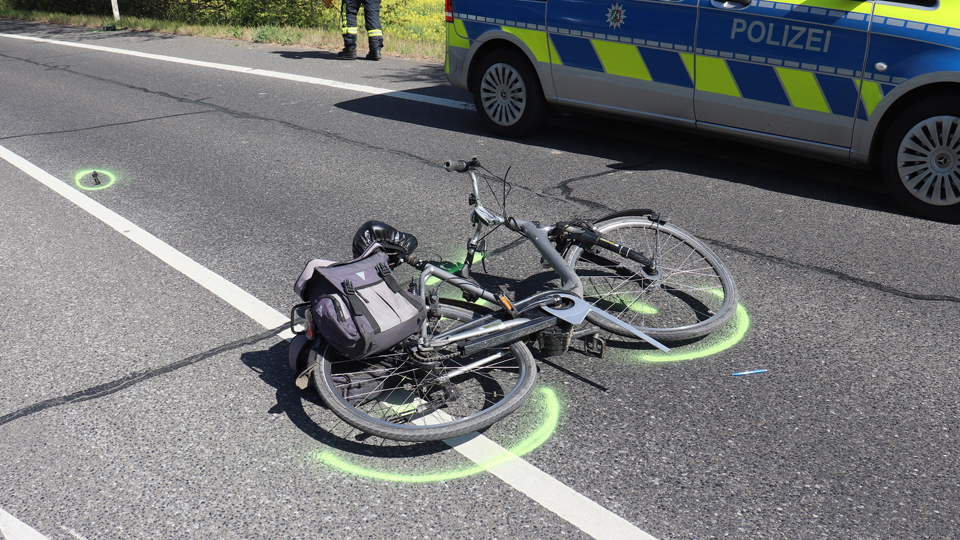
top-left (0, 0), bottom-right (444, 62)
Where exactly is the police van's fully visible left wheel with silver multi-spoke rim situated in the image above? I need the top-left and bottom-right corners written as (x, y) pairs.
top-left (473, 49), bottom-right (548, 138)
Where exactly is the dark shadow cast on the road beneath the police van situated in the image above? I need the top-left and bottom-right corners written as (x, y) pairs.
top-left (337, 88), bottom-right (906, 219)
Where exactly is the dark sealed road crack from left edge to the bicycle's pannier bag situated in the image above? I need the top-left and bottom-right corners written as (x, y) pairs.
top-left (0, 324), bottom-right (289, 426)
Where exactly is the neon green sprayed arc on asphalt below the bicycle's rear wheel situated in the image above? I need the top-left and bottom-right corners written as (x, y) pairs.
top-left (316, 388), bottom-right (560, 484)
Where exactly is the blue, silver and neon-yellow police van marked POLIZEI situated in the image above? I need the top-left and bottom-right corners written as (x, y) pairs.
top-left (445, 0), bottom-right (960, 222)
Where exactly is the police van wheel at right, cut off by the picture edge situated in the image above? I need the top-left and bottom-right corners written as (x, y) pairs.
top-left (879, 95), bottom-right (960, 223)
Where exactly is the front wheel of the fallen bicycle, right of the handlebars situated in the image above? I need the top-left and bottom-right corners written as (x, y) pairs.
top-left (564, 215), bottom-right (737, 341)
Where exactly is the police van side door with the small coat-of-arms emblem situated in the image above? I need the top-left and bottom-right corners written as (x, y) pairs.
top-left (547, 0), bottom-right (697, 123)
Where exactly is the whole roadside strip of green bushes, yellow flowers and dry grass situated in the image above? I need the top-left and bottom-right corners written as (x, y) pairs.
top-left (0, 0), bottom-right (444, 61)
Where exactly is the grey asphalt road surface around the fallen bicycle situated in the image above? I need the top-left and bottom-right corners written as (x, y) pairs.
top-left (0, 21), bottom-right (960, 540)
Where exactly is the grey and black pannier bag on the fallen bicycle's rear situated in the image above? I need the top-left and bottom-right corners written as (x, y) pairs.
top-left (294, 244), bottom-right (427, 359)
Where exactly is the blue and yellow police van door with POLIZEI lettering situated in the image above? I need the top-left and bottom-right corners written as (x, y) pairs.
top-left (694, 0), bottom-right (873, 148)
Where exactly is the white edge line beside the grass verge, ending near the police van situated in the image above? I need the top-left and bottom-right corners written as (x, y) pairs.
top-left (0, 33), bottom-right (476, 111)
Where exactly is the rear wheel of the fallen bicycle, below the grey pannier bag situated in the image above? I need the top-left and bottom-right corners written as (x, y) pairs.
top-left (313, 299), bottom-right (537, 442)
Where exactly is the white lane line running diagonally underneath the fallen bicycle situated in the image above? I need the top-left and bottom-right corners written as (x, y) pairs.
top-left (0, 146), bottom-right (653, 540)
